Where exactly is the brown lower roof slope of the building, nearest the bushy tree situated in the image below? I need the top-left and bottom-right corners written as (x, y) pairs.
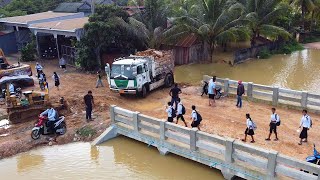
top-left (29, 17), bottom-right (89, 32)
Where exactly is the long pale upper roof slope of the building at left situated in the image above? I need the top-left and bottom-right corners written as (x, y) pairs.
top-left (0, 11), bottom-right (84, 25)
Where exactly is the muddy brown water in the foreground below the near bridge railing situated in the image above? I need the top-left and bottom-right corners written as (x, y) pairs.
top-left (0, 137), bottom-right (223, 180)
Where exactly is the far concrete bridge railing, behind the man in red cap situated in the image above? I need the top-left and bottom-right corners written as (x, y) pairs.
top-left (203, 75), bottom-right (320, 112)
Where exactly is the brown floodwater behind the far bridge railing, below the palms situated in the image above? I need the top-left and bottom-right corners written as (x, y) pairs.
top-left (175, 49), bottom-right (320, 93)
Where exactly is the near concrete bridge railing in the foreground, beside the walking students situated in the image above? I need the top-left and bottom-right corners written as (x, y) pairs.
top-left (110, 105), bottom-right (320, 180)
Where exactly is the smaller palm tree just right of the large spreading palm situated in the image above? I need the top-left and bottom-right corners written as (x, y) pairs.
top-left (238, 0), bottom-right (290, 45)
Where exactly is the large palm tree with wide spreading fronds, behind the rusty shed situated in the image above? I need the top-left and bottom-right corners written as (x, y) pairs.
top-left (164, 0), bottom-right (248, 60)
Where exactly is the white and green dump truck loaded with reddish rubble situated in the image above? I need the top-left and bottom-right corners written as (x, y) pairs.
top-left (105, 49), bottom-right (174, 97)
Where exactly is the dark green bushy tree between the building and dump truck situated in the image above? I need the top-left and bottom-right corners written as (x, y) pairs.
top-left (77, 5), bottom-right (147, 70)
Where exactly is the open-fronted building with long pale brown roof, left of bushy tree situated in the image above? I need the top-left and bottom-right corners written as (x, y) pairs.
top-left (0, 11), bottom-right (88, 63)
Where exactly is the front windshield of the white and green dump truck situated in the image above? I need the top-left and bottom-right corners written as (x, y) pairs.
top-left (110, 64), bottom-right (134, 79)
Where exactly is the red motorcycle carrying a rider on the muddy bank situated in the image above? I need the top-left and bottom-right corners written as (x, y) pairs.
top-left (31, 116), bottom-right (67, 140)
